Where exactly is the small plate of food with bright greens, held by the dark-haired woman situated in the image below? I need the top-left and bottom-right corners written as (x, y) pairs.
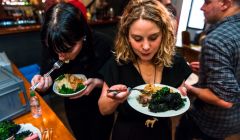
top-left (53, 74), bottom-right (87, 97)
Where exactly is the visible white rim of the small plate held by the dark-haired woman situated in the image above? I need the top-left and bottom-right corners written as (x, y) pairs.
top-left (53, 74), bottom-right (87, 97)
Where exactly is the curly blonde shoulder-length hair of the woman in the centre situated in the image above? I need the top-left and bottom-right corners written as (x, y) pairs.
top-left (114, 0), bottom-right (176, 67)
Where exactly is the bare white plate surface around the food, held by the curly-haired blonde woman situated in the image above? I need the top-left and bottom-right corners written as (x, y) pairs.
top-left (127, 84), bottom-right (190, 117)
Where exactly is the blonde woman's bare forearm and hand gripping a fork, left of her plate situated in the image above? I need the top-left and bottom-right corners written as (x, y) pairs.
top-left (98, 82), bottom-right (129, 115)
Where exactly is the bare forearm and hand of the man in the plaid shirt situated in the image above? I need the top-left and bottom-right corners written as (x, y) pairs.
top-left (184, 84), bottom-right (233, 108)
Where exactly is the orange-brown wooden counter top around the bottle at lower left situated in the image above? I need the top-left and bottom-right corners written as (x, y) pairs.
top-left (12, 65), bottom-right (75, 140)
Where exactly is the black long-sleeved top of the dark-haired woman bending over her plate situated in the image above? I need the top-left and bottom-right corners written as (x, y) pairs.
top-left (41, 32), bottom-right (113, 140)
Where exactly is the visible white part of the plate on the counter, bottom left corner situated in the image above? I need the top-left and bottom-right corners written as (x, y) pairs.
top-left (17, 123), bottom-right (42, 140)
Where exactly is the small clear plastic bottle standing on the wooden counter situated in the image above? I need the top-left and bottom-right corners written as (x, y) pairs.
top-left (29, 91), bottom-right (42, 118)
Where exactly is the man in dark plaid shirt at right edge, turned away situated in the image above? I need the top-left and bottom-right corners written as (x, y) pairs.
top-left (175, 0), bottom-right (240, 140)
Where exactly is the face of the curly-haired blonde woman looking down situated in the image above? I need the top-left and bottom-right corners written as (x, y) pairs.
top-left (128, 19), bottom-right (162, 61)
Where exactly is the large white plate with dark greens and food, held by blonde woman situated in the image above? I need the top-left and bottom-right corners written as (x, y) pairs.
top-left (127, 84), bottom-right (190, 117)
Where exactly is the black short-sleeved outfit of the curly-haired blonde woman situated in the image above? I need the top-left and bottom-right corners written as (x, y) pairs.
top-left (101, 55), bottom-right (191, 140)
